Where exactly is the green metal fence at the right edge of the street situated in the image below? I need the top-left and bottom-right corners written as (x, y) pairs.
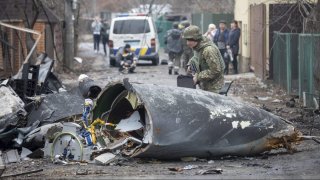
top-left (272, 32), bottom-right (320, 107)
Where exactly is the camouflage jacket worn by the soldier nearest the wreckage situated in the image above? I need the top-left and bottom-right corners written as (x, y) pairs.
top-left (189, 37), bottom-right (224, 93)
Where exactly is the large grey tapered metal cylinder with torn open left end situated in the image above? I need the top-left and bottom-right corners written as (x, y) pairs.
top-left (93, 83), bottom-right (300, 159)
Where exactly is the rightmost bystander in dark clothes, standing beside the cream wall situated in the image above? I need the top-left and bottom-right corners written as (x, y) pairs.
top-left (227, 20), bottom-right (241, 74)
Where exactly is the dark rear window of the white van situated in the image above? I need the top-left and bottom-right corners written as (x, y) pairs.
top-left (113, 19), bottom-right (150, 34)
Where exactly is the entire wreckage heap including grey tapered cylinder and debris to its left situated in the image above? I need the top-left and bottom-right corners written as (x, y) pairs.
top-left (0, 23), bottom-right (310, 172)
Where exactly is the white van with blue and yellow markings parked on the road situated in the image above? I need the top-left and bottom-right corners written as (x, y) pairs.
top-left (109, 14), bottom-right (160, 66)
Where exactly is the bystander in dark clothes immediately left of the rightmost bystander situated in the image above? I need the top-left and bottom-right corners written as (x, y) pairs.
top-left (213, 20), bottom-right (229, 74)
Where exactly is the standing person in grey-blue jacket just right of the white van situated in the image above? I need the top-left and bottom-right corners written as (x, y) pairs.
top-left (165, 23), bottom-right (182, 75)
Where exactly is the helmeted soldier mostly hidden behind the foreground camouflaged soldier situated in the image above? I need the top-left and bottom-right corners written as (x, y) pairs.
top-left (180, 21), bottom-right (193, 71)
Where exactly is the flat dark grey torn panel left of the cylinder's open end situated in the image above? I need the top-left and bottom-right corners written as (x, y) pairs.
top-left (28, 90), bottom-right (84, 126)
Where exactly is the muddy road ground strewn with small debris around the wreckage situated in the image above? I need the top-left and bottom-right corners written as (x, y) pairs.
top-left (3, 43), bottom-right (320, 179)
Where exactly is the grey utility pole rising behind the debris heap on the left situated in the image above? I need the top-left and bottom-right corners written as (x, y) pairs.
top-left (64, 0), bottom-right (74, 69)
